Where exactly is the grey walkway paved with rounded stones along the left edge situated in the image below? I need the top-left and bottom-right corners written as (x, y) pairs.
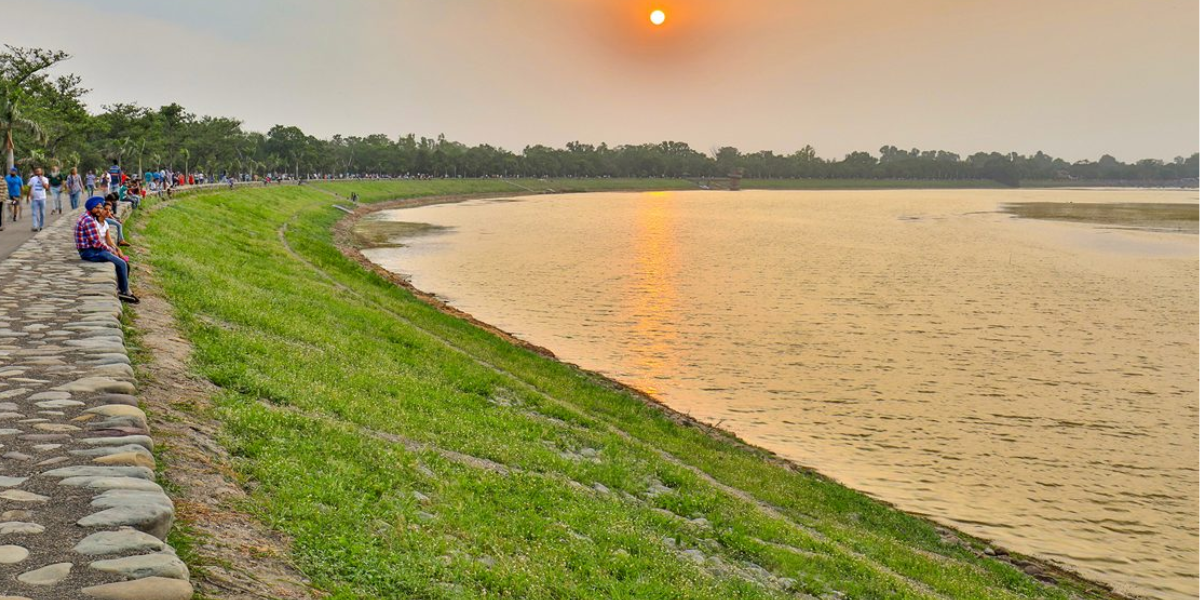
top-left (0, 211), bottom-right (192, 600)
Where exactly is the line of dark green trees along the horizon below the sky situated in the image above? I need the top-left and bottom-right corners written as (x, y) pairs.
top-left (0, 46), bottom-right (1200, 186)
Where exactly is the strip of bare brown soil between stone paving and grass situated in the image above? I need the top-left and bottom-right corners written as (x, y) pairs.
top-left (133, 252), bottom-right (322, 600)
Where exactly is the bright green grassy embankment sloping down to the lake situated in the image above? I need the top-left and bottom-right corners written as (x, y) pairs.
top-left (140, 181), bottom-right (1108, 599)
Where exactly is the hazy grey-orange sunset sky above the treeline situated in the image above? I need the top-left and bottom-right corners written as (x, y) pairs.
top-left (0, 0), bottom-right (1200, 160)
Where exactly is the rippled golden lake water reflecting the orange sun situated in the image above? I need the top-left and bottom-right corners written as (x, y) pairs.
top-left (367, 191), bottom-right (1200, 600)
